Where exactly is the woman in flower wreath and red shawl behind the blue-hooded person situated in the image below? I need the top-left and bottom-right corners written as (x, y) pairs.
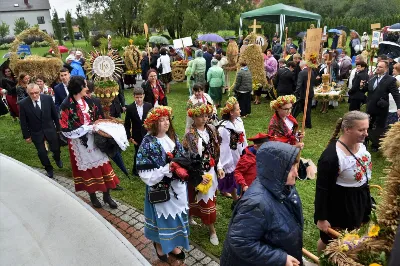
top-left (268, 95), bottom-right (316, 179)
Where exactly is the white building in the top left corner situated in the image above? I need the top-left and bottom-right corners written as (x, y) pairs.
top-left (0, 0), bottom-right (53, 35)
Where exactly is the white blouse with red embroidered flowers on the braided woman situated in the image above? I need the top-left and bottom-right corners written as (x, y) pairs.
top-left (336, 144), bottom-right (372, 187)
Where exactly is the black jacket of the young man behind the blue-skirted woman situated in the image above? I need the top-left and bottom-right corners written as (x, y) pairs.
top-left (125, 102), bottom-right (153, 143)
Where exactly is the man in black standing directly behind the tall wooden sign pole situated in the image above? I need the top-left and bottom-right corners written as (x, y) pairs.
top-left (292, 61), bottom-right (315, 128)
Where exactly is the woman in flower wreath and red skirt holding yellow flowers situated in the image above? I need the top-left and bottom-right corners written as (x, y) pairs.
top-left (183, 103), bottom-right (224, 246)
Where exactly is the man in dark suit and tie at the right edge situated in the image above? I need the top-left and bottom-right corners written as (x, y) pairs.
top-left (361, 61), bottom-right (400, 152)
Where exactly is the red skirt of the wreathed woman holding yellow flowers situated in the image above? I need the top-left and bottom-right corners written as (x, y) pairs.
top-left (188, 185), bottom-right (217, 225)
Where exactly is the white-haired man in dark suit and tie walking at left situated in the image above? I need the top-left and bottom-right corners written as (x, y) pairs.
top-left (19, 83), bottom-right (63, 178)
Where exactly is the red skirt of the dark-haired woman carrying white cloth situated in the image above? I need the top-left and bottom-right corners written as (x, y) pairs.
top-left (68, 141), bottom-right (119, 193)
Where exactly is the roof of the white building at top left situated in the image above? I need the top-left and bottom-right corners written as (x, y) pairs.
top-left (0, 0), bottom-right (51, 12)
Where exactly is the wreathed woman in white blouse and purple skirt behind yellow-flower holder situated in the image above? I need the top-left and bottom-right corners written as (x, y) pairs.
top-left (218, 97), bottom-right (247, 206)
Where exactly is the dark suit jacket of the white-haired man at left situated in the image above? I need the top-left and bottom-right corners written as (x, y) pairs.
top-left (19, 94), bottom-right (60, 142)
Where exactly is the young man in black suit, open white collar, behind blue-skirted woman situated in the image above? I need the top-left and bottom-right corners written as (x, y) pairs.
top-left (125, 88), bottom-right (152, 175)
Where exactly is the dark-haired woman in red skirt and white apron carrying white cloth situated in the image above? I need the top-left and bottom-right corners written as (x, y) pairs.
top-left (60, 76), bottom-right (119, 209)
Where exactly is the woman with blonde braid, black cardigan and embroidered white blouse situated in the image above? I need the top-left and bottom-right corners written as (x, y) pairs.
top-left (314, 111), bottom-right (372, 253)
